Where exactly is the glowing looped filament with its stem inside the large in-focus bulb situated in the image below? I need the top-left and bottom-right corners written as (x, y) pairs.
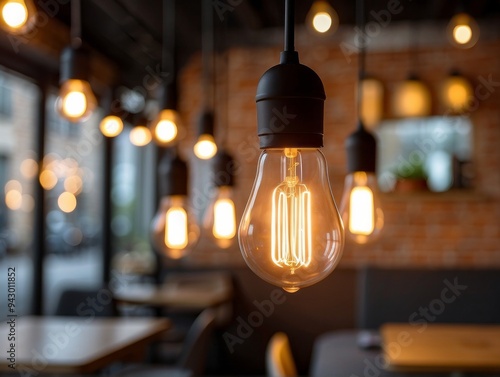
top-left (271, 149), bottom-right (312, 270)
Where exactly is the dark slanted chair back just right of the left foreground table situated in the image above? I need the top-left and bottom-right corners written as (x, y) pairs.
top-left (178, 309), bottom-right (216, 376)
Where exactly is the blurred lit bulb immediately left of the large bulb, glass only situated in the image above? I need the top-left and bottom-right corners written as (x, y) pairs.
top-left (203, 186), bottom-right (237, 249)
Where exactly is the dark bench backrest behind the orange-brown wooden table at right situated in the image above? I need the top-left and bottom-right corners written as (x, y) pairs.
top-left (358, 267), bottom-right (500, 329)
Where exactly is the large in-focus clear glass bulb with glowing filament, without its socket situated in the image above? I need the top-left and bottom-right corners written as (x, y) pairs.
top-left (238, 148), bottom-right (344, 292)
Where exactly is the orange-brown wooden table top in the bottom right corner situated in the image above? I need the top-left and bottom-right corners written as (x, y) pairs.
top-left (380, 323), bottom-right (500, 372)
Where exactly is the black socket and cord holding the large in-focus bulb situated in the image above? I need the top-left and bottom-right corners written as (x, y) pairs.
top-left (255, 0), bottom-right (326, 149)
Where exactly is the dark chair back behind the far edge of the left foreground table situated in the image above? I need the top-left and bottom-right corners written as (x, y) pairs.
top-left (55, 288), bottom-right (118, 317)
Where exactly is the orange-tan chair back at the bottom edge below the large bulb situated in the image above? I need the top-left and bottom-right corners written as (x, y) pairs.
top-left (266, 332), bottom-right (297, 377)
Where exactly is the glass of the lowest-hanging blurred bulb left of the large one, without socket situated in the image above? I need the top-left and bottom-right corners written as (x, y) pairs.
top-left (151, 195), bottom-right (200, 259)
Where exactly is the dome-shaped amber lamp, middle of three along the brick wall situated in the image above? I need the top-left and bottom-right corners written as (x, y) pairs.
top-left (392, 79), bottom-right (431, 117)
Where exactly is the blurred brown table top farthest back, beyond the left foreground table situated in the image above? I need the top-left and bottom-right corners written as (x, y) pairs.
top-left (113, 273), bottom-right (232, 310)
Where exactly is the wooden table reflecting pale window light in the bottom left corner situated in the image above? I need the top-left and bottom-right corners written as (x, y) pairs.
top-left (0, 317), bottom-right (170, 375)
